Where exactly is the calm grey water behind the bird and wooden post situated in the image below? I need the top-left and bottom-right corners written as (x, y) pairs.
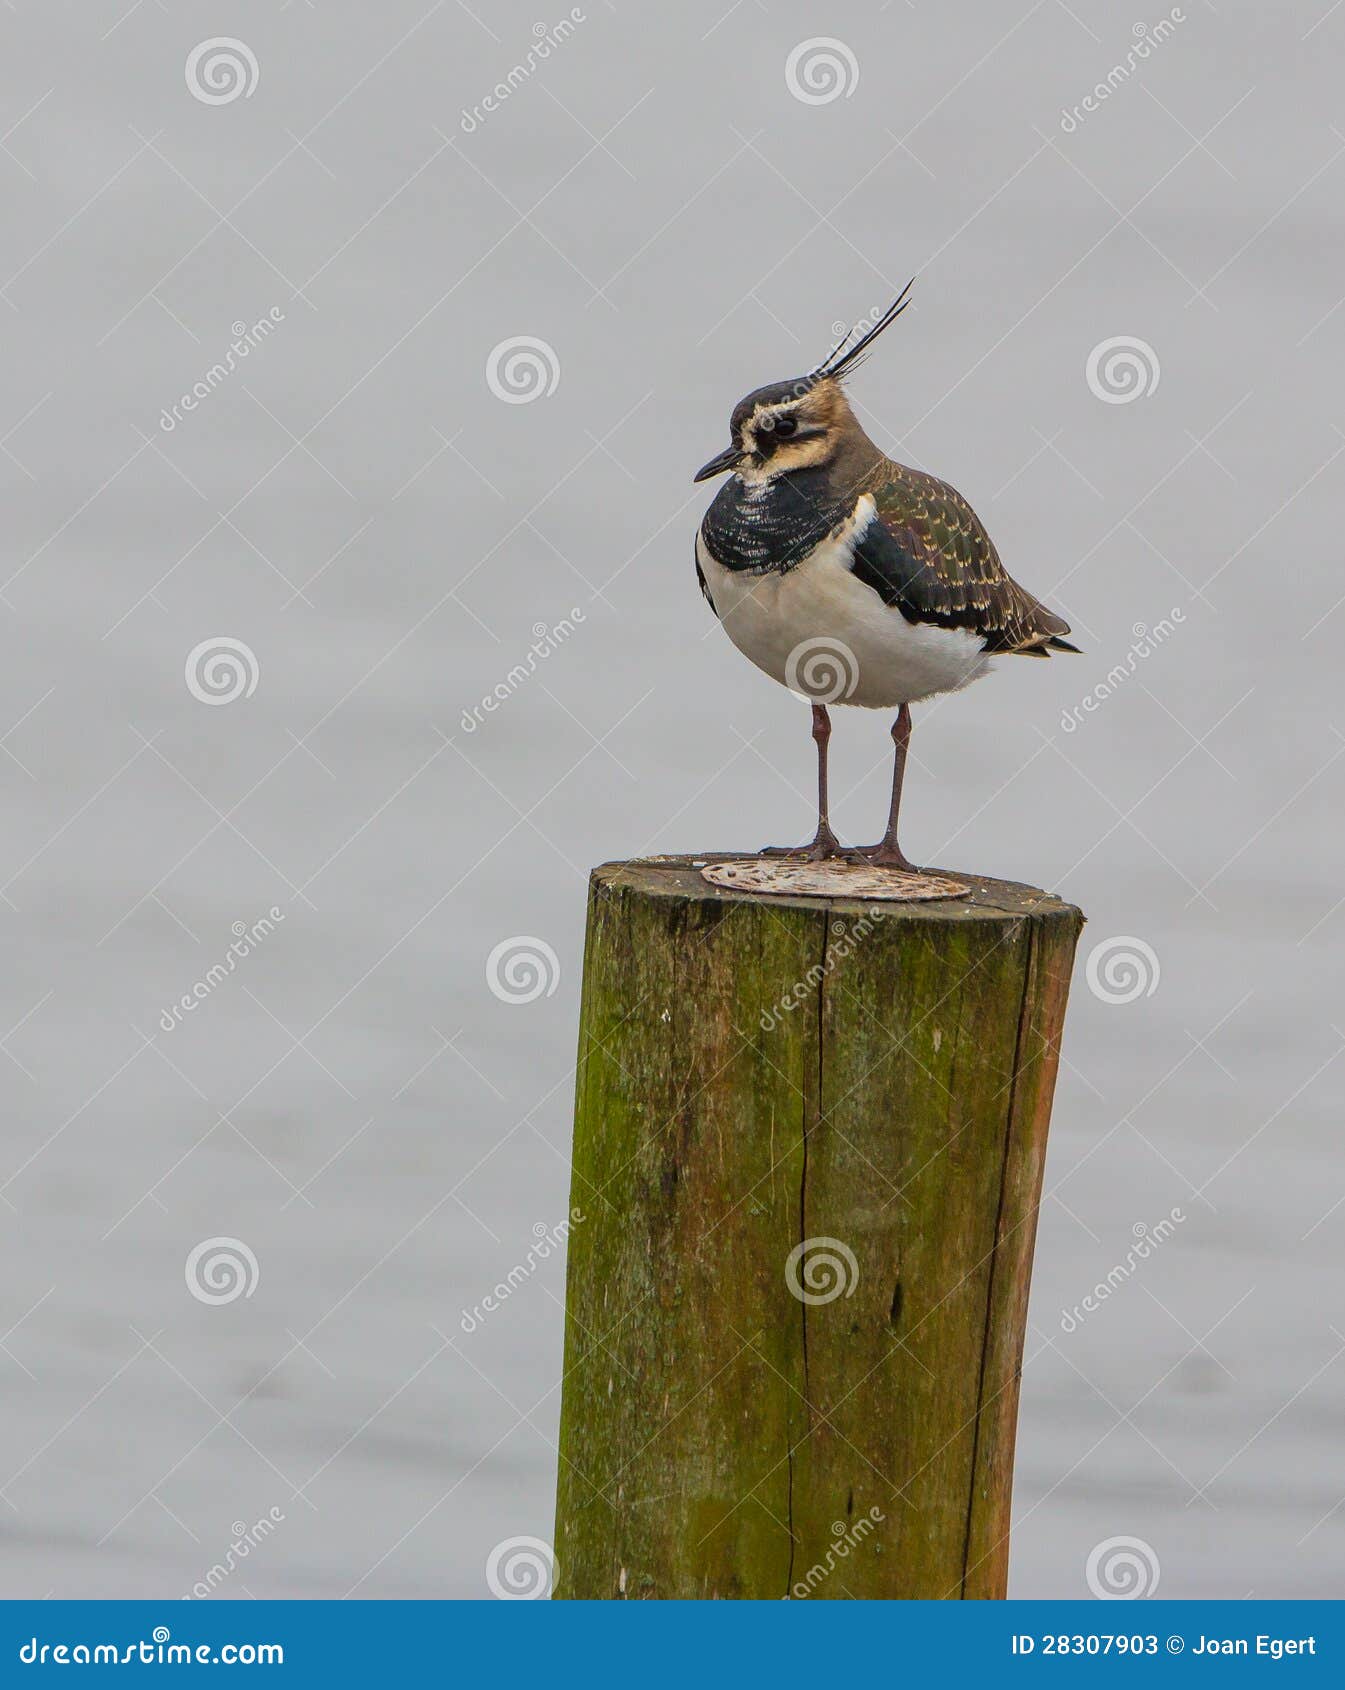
top-left (0, 0), bottom-right (1345, 1597)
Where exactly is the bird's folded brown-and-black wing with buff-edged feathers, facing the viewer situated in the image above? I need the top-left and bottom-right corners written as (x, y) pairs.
top-left (852, 465), bottom-right (1075, 656)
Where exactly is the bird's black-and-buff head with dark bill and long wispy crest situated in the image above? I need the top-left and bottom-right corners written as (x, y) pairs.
top-left (693, 282), bottom-right (911, 482)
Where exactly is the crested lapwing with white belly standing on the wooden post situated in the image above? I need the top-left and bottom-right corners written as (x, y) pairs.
top-left (693, 277), bottom-right (1080, 874)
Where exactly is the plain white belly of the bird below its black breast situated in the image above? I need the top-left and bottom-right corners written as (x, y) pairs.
top-left (696, 500), bottom-right (990, 710)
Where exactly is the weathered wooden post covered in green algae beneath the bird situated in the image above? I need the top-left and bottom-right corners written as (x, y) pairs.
top-left (556, 859), bottom-right (1083, 1599)
